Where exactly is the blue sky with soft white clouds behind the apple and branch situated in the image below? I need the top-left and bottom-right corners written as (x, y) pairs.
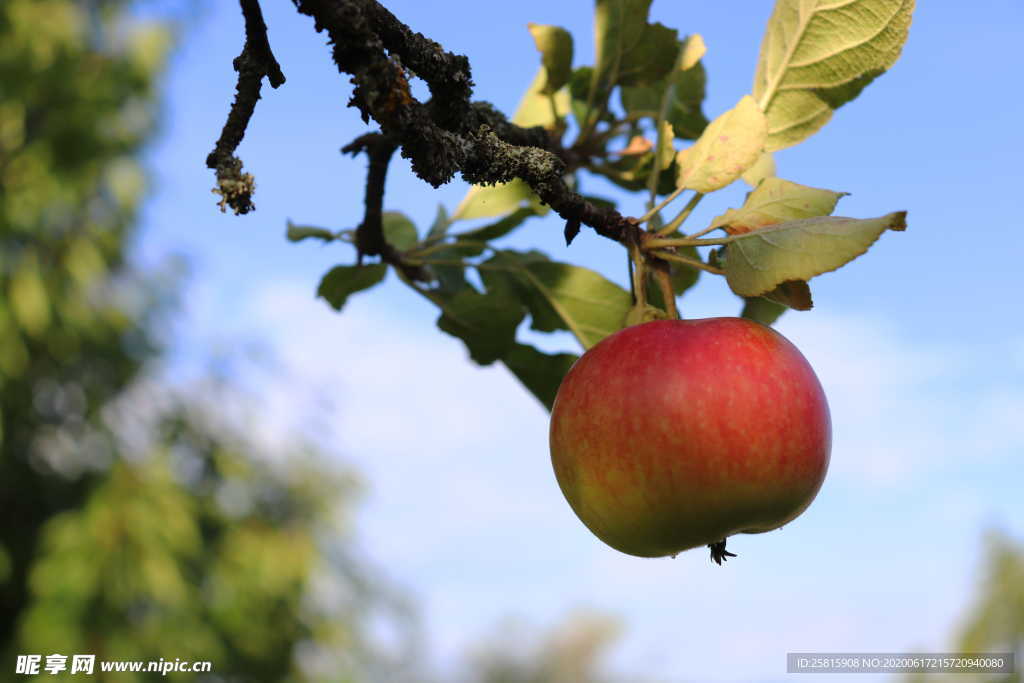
top-left (138, 0), bottom-right (1024, 681)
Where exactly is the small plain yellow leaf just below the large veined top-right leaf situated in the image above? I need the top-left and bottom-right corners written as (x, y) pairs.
top-left (676, 95), bottom-right (767, 195)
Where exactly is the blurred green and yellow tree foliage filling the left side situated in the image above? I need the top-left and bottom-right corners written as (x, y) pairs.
top-left (0, 0), bottom-right (412, 683)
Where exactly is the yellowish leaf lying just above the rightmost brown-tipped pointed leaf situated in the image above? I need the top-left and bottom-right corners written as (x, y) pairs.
top-left (711, 177), bottom-right (849, 234)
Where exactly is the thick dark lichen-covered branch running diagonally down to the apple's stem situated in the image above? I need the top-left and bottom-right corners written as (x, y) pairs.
top-left (284, 0), bottom-right (640, 245)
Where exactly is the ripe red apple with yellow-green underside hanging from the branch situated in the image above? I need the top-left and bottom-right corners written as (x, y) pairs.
top-left (550, 317), bottom-right (831, 557)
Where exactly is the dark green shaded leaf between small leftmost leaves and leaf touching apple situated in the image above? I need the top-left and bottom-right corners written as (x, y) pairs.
top-left (432, 286), bottom-right (523, 366)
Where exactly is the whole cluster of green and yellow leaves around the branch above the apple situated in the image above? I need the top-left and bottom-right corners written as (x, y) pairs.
top-left (289, 0), bottom-right (913, 408)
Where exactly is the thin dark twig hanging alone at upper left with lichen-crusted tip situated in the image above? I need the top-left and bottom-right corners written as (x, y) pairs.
top-left (206, 0), bottom-right (285, 214)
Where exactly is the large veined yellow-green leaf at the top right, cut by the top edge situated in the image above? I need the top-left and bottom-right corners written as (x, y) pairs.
top-left (754, 0), bottom-right (914, 152)
